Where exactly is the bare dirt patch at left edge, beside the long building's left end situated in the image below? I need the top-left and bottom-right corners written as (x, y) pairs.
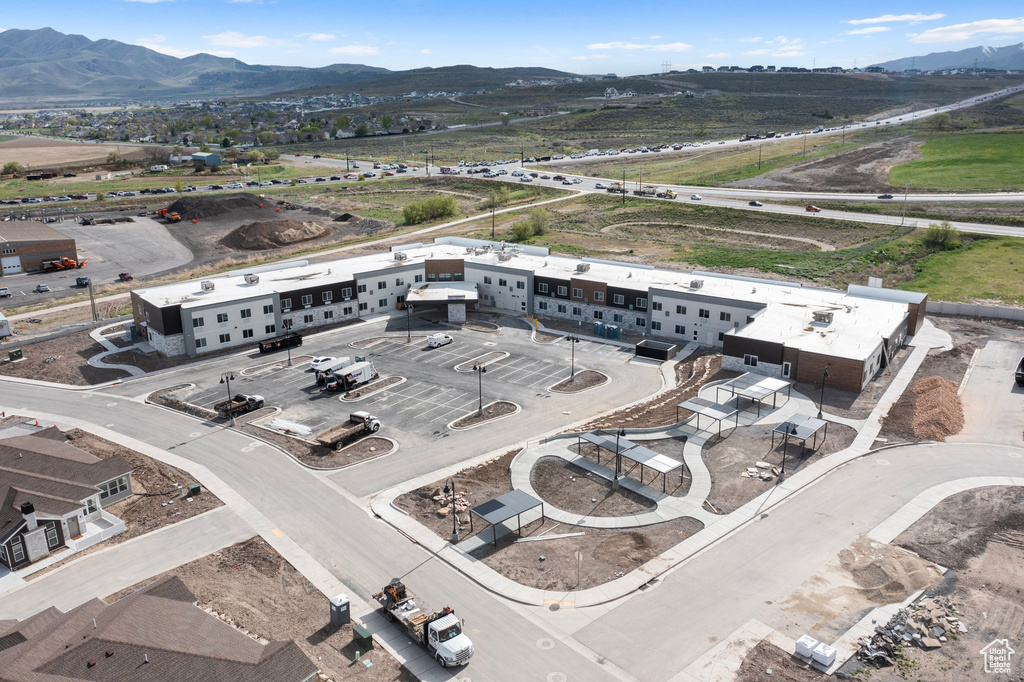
top-left (0, 332), bottom-right (129, 386)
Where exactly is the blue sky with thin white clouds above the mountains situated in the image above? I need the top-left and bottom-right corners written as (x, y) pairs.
top-left (0, 0), bottom-right (1024, 76)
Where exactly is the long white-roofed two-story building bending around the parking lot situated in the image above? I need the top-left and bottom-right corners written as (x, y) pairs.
top-left (132, 238), bottom-right (926, 391)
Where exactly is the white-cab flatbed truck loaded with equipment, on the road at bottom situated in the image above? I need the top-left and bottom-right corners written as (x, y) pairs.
top-left (374, 581), bottom-right (473, 668)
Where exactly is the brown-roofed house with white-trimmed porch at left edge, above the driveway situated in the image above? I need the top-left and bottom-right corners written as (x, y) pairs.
top-left (0, 427), bottom-right (132, 570)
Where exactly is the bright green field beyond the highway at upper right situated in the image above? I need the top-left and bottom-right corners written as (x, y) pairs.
top-left (889, 134), bottom-right (1024, 189)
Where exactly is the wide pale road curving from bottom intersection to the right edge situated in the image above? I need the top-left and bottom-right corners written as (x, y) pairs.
top-left (569, 444), bottom-right (1024, 681)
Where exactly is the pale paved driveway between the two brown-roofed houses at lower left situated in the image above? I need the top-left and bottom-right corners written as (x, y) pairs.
top-left (0, 503), bottom-right (255, 620)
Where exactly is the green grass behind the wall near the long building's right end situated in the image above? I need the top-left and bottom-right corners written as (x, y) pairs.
top-left (899, 237), bottom-right (1024, 305)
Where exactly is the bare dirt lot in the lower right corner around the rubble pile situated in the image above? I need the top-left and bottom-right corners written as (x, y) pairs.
top-left (861, 486), bottom-right (1024, 682)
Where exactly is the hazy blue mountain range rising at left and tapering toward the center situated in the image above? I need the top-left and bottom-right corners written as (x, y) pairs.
top-left (0, 28), bottom-right (573, 101)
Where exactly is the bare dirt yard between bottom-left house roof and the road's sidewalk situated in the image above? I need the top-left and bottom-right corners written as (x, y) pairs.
top-left (105, 538), bottom-right (417, 682)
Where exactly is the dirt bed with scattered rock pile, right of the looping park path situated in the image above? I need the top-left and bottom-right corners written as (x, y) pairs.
top-left (701, 423), bottom-right (857, 514)
